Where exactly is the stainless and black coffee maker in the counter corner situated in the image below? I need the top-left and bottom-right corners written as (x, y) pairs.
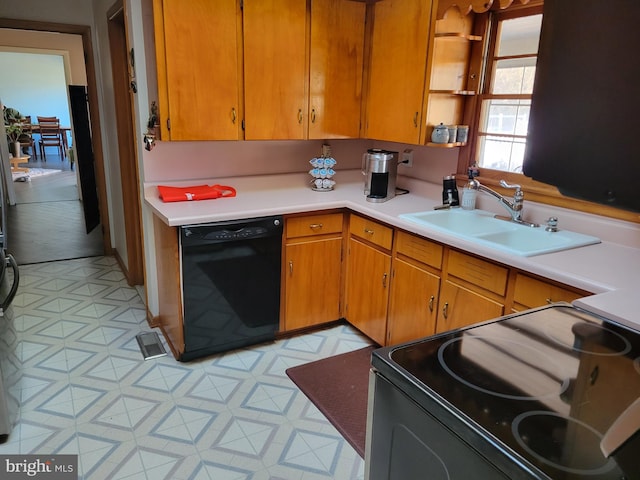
top-left (362, 148), bottom-right (398, 202)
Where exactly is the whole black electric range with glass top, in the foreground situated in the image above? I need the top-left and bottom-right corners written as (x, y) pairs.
top-left (366, 304), bottom-right (640, 480)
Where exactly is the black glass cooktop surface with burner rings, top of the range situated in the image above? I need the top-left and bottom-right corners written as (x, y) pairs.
top-left (390, 305), bottom-right (640, 480)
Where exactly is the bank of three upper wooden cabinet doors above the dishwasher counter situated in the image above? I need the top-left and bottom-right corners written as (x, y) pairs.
top-left (154, 0), bottom-right (366, 140)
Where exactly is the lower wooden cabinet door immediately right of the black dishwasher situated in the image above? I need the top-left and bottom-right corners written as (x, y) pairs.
top-left (284, 238), bottom-right (342, 330)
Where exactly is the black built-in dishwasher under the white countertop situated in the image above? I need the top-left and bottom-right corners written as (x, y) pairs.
top-left (179, 216), bottom-right (283, 361)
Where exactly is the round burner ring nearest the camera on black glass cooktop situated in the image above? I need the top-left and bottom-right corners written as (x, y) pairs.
top-left (511, 410), bottom-right (616, 476)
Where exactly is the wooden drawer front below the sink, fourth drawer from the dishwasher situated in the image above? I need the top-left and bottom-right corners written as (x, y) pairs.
top-left (448, 250), bottom-right (509, 295)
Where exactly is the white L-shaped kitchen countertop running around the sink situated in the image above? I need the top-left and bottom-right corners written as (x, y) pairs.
top-left (145, 170), bottom-right (640, 328)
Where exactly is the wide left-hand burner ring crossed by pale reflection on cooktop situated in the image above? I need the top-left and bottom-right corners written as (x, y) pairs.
top-left (438, 334), bottom-right (570, 400)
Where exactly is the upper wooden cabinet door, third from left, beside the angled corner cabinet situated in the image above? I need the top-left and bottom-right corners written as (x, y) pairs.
top-left (309, 0), bottom-right (366, 139)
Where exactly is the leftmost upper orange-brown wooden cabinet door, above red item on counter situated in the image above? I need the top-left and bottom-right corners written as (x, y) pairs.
top-left (154, 0), bottom-right (242, 140)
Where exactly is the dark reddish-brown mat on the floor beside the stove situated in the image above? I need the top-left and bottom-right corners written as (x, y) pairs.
top-left (286, 346), bottom-right (378, 458)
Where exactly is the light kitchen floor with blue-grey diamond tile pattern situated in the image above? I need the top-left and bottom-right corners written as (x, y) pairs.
top-left (0, 257), bottom-right (369, 480)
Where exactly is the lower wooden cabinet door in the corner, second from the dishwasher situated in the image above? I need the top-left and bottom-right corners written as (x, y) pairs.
top-left (346, 238), bottom-right (391, 345)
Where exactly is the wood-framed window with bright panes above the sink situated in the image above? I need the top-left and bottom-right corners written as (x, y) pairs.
top-left (476, 10), bottom-right (542, 173)
